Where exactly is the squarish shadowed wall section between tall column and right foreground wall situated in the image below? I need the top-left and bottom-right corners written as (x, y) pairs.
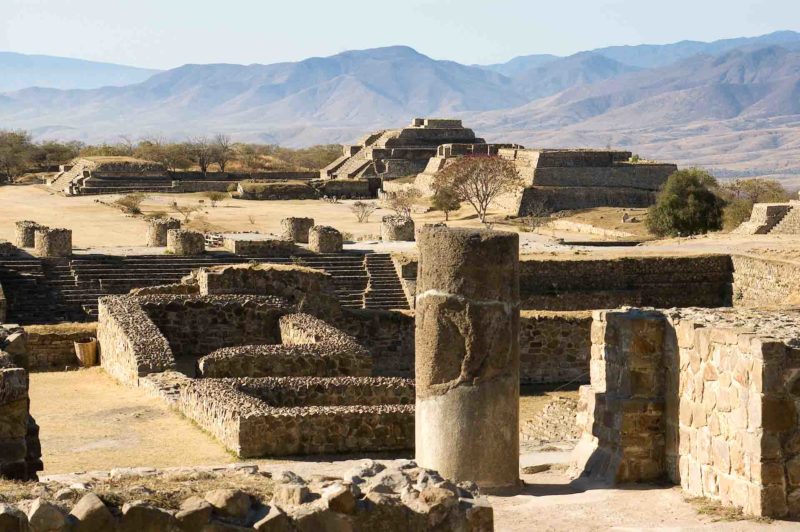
top-left (519, 311), bottom-right (592, 384)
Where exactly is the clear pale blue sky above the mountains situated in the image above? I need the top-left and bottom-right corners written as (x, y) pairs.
top-left (0, 0), bottom-right (800, 68)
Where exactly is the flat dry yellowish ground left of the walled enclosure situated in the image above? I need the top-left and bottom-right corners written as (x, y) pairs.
top-left (30, 368), bottom-right (235, 474)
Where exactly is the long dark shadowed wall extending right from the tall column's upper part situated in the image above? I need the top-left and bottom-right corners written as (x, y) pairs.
top-left (520, 255), bottom-right (733, 310)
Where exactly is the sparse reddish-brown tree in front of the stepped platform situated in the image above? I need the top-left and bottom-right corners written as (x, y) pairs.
top-left (433, 156), bottom-right (523, 223)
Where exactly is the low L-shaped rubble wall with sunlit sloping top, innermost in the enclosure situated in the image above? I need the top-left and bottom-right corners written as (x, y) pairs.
top-left (198, 314), bottom-right (372, 378)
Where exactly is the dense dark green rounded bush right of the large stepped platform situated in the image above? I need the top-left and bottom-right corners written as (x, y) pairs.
top-left (647, 168), bottom-right (725, 236)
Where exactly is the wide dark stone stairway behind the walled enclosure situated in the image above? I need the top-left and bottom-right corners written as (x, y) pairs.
top-left (0, 252), bottom-right (408, 324)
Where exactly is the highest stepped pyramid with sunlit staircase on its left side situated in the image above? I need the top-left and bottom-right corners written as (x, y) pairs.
top-left (320, 118), bottom-right (485, 180)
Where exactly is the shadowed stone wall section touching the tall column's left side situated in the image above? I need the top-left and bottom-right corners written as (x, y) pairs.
top-left (335, 309), bottom-right (414, 377)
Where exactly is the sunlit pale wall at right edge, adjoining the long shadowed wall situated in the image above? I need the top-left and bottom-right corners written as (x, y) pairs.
top-left (731, 255), bottom-right (800, 307)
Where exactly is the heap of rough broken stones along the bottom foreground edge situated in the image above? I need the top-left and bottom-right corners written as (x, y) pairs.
top-left (0, 460), bottom-right (494, 532)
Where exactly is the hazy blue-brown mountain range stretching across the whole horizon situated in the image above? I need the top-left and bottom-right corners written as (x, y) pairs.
top-left (0, 31), bottom-right (800, 185)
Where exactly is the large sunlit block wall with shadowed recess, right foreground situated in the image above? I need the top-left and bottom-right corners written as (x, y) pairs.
top-left (576, 309), bottom-right (800, 518)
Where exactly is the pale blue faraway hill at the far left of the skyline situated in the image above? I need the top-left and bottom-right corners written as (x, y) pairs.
top-left (0, 52), bottom-right (158, 92)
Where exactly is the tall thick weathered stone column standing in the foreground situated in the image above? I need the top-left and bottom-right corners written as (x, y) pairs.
top-left (416, 226), bottom-right (519, 492)
